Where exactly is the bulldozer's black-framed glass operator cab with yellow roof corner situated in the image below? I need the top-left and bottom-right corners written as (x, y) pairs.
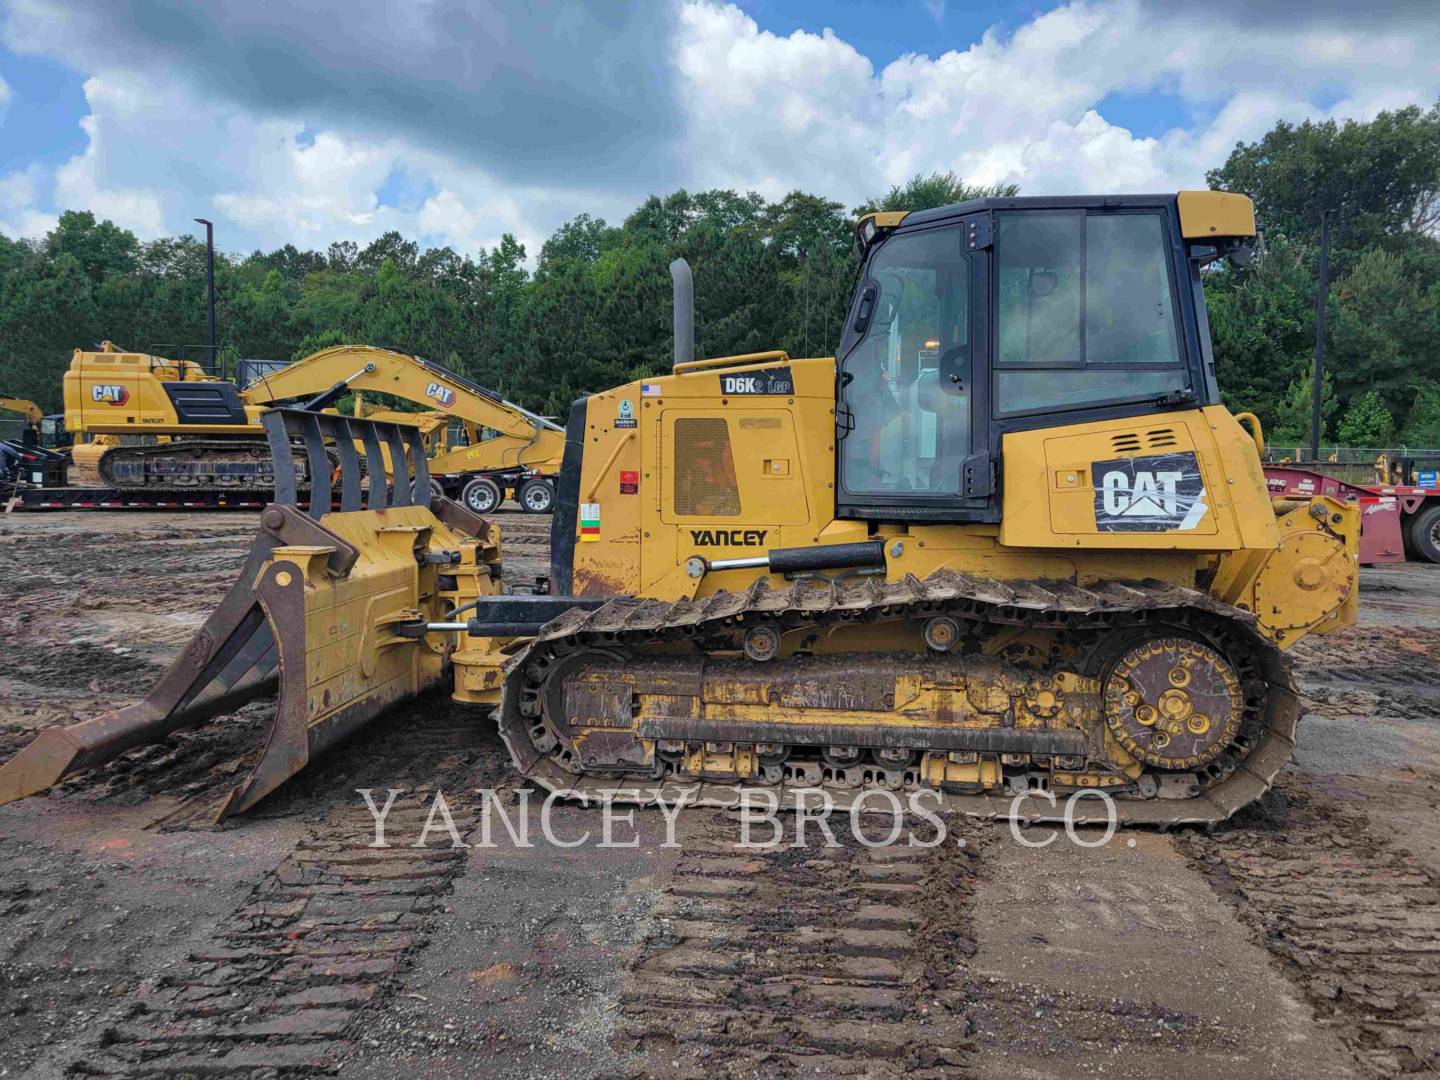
top-left (837, 192), bottom-right (1254, 521)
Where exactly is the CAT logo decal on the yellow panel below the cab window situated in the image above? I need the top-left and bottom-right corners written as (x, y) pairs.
top-left (1093, 452), bottom-right (1207, 533)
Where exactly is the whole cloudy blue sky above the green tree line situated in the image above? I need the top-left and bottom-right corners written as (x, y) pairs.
top-left (0, 0), bottom-right (1440, 251)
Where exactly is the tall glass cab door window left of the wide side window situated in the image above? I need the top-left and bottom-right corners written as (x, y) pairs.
top-left (841, 225), bottom-right (971, 494)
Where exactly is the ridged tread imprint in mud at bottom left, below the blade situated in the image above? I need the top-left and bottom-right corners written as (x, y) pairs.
top-left (66, 717), bottom-right (498, 1076)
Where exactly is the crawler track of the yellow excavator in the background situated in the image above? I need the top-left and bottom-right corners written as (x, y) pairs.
top-left (99, 438), bottom-right (338, 490)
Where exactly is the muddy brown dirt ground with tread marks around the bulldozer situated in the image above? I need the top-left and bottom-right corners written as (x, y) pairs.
top-left (0, 514), bottom-right (1440, 1080)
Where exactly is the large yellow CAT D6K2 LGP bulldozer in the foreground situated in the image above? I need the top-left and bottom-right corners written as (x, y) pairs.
top-left (0, 192), bottom-right (1359, 827)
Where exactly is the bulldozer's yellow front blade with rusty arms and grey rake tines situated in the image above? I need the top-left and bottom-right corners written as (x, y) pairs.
top-left (0, 409), bottom-right (494, 819)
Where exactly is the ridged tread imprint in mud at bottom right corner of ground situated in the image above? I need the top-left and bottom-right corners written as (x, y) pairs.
top-left (1181, 782), bottom-right (1440, 1077)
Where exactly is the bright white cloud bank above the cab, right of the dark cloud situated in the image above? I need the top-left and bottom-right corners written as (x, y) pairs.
top-left (677, 0), bottom-right (1440, 204)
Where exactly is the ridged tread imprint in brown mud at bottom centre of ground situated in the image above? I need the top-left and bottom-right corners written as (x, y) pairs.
top-left (621, 812), bottom-right (979, 1077)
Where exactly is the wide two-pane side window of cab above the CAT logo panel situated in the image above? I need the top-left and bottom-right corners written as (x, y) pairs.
top-left (995, 210), bottom-right (1189, 416)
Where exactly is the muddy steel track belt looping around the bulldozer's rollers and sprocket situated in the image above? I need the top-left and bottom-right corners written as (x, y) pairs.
top-left (500, 572), bottom-right (1300, 827)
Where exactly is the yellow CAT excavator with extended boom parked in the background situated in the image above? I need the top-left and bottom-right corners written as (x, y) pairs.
top-left (65, 341), bottom-right (564, 513)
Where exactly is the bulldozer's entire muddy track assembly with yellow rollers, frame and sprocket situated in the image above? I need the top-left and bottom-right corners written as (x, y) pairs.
top-left (500, 570), bottom-right (1300, 827)
